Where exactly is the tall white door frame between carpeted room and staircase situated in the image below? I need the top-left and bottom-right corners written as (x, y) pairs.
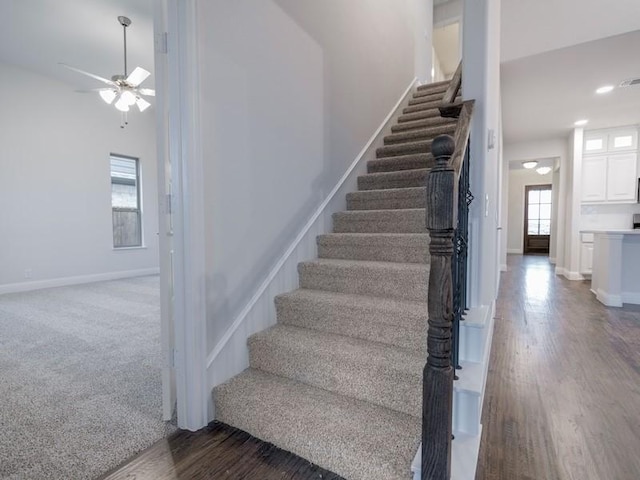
top-left (154, 0), bottom-right (210, 431)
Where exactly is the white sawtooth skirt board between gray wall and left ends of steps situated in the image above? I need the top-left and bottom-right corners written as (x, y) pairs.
top-left (207, 79), bottom-right (416, 408)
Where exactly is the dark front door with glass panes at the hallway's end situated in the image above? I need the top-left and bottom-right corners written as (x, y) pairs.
top-left (523, 185), bottom-right (551, 255)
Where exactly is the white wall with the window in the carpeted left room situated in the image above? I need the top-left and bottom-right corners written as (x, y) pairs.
top-left (0, 64), bottom-right (158, 291)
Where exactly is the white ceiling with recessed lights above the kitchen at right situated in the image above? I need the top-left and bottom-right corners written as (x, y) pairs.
top-left (501, 28), bottom-right (640, 143)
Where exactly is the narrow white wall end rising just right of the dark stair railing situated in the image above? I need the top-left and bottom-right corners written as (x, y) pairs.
top-left (462, 0), bottom-right (502, 307)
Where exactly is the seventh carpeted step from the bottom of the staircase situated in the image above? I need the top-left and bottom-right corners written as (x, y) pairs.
top-left (347, 187), bottom-right (427, 210)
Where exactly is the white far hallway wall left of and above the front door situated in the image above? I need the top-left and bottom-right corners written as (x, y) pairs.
top-left (507, 169), bottom-right (555, 254)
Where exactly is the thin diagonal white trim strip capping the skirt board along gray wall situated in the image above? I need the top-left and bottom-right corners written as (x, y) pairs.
top-left (206, 78), bottom-right (418, 368)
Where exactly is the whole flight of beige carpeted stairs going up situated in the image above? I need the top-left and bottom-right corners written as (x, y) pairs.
top-left (214, 82), bottom-right (456, 480)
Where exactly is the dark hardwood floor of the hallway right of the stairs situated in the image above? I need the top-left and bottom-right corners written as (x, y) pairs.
top-left (476, 256), bottom-right (640, 480)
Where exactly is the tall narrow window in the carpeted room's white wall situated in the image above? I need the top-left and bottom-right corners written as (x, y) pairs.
top-left (111, 155), bottom-right (142, 248)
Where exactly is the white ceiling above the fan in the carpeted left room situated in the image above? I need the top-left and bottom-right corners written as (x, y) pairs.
top-left (0, 0), bottom-right (153, 88)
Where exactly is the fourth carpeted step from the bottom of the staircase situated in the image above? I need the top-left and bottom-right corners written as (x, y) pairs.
top-left (298, 258), bottom-right (429, 302)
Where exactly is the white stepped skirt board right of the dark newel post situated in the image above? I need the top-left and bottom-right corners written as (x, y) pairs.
top-left (411, 305), bottom-right (495, 480)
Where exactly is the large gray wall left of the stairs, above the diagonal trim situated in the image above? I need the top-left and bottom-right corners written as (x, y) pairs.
top-left (198, 0), bottom-right (415, 349)
